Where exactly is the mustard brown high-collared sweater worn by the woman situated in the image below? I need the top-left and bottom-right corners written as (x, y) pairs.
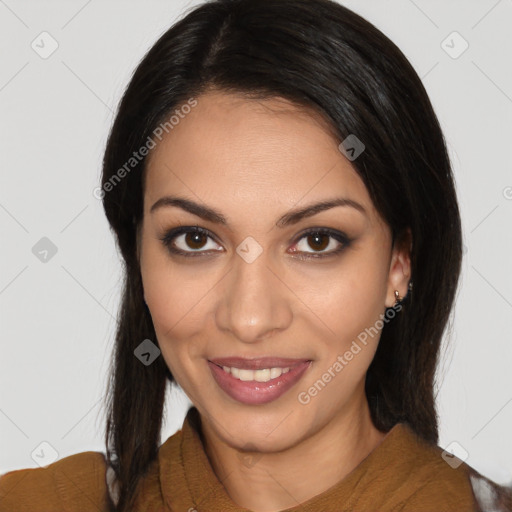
top-left (0, 407), bottom-right (498, 512)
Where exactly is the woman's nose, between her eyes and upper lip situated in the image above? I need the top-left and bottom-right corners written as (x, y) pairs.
top-left (216, 247), bottom-right (294, 343)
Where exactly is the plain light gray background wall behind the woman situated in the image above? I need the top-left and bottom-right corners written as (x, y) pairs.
top-left (0, 0), bottom-right (512, 483)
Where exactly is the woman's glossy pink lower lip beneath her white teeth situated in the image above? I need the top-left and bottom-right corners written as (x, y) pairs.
top-left (208, 361), bottom-right (311, 405)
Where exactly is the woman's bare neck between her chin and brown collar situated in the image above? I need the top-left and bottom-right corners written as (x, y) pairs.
top-left (203, 390), bottom-right (386, 512)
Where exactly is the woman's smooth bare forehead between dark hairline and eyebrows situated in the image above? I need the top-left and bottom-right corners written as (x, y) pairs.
top-left (145, 92), bottom-right (372, 220)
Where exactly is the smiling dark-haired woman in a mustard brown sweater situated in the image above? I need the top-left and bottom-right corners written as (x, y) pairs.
top-left (0, 0), bottom-right (508, 512)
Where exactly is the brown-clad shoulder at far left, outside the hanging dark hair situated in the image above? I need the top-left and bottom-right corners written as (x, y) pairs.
top-left (0, 451), bottom-right (107, 512)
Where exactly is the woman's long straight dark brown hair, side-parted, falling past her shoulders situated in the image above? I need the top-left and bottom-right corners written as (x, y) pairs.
top-left (101, 0), bottom-right (462, 511)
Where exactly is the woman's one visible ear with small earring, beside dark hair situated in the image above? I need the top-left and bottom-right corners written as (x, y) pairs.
top-left (386, 227), bottom-right (412, 308)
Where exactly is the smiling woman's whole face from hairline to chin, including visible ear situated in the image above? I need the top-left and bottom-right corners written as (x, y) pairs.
top-left (139, 92), bottom-right (408, 451)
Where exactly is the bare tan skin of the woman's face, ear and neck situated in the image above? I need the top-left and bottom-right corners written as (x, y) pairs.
top-left (138, 91), bottom-right (410, 512)
